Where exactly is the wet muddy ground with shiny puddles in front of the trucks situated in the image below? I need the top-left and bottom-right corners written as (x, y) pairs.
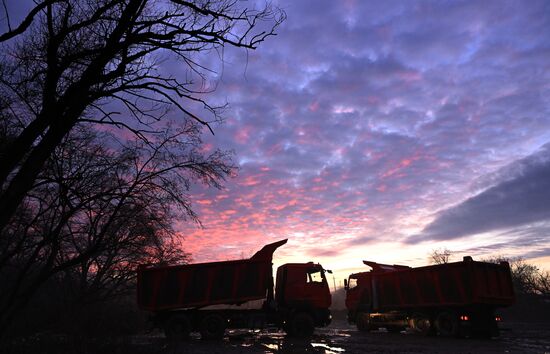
top-left (134, 321), bottom-right (550, 354)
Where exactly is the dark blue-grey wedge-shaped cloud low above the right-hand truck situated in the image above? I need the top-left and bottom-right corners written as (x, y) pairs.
top-left (416, 145), bottom-right (550, 242)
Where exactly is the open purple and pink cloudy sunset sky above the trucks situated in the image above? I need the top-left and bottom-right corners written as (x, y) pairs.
top-left (177, 0), bottom-right (550, 279)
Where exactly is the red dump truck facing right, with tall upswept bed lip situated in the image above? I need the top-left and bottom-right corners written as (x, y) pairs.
top-left (137, 240), bottom-right (331, 339)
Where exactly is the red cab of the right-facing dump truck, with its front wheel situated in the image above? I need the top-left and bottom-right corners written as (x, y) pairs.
top-left (275, 262), bottom-right (331, 336)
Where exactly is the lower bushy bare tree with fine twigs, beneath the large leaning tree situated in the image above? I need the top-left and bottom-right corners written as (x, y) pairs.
top-left (0, 120), bottom-right (234, 334)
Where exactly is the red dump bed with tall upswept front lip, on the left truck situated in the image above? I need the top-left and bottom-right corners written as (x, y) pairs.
top-left (138, 240), bottom-right (287, 311)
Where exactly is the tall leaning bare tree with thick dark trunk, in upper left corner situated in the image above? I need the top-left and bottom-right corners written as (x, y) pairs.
top-left (0, 0), bottom-right (285, 235)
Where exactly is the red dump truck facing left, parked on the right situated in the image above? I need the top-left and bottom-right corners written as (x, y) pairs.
top-left (344, 257), bottom-right (514, 337)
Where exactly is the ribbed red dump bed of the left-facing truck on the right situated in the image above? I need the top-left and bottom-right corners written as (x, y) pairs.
top-left (372, 260), bottom-right (514, 310)
